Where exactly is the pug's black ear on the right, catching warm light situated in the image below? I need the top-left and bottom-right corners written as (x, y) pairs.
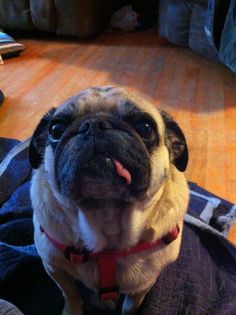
top-left (160, 111), bottom-right (188, 172)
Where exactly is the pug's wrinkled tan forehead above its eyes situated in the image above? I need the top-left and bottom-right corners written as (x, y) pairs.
top-left (55, 86), bottom-right (164, 134)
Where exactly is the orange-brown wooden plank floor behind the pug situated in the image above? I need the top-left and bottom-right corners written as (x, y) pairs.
top-left (0, 31), bottom-right (236, 242)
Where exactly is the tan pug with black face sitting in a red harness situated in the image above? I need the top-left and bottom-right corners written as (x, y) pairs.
top-left (29, 87), bottom-right (189, 315)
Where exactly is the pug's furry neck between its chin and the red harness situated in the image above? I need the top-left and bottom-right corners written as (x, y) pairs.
top-left (34, 168), bottom-right (187, 252)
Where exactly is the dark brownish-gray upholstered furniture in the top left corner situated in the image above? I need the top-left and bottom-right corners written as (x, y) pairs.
top-left (0, 0), bottom-right (113, 37)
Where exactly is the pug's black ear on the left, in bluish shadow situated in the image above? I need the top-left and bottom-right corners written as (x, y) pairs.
top-left (29, 108), bottom-right (56, 168)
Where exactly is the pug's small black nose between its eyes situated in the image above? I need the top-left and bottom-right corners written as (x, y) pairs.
top-left (78, 118), bottom-right (112, 135)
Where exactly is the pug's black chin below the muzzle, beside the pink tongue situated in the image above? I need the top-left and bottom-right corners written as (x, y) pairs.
top-left (56, 155), bottom-right (140, 208)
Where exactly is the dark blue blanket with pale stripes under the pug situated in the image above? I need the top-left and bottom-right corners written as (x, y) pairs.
top-left (0, 138), bottom-right (236, 315)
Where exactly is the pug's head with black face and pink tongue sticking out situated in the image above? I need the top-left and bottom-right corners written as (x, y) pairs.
top-left (29, 87), bottom-right (188, 207)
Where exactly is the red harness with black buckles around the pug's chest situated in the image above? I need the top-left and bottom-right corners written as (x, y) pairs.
top-left (40, 225), bottom-right (179, 300)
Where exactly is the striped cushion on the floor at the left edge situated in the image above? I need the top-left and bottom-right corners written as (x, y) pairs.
top-left (0, 31), bottom-right (25, 58)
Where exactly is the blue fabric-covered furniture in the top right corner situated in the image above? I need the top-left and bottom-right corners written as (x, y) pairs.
top-left (158, 0), bottom-right (236, 72)
